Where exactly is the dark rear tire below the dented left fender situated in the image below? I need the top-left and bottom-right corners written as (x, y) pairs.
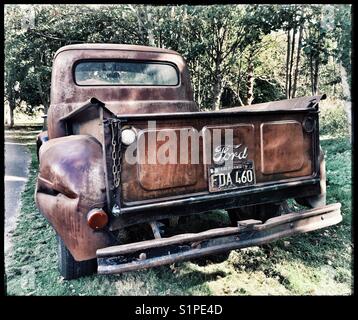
top-left (57, 235), bottom-right (97, 280)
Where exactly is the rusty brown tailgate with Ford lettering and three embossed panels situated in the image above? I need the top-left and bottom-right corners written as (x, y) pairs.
top-left (117, 96), bottom-right (324, 206)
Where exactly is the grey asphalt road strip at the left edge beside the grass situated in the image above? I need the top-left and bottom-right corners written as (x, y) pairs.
top-left (4, 138), bottom-right (30, 252)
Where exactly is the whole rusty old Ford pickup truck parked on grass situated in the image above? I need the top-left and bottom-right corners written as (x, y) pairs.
top-left (35, 44), bottom-right (342, 279)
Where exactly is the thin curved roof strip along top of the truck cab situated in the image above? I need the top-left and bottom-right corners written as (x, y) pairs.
top-left (55, 43), bottom-right (179, 57)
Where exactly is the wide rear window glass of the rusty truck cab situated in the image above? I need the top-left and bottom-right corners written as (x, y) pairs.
top-left (74, 60), bottom-right (179, 86)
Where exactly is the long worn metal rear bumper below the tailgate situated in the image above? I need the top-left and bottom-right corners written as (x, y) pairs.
top-left (97, 203), bottom-right (342, 274)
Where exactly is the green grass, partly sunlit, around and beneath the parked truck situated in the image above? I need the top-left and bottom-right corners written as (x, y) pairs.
top-left (6, 126), bottom-right (353, 295)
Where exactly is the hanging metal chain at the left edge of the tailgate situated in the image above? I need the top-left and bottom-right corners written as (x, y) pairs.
top-left (111, 119), bottom-right (122, 188)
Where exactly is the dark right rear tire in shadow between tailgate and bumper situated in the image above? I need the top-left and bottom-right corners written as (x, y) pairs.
top-left (227, 203), bottom-right (284, 226)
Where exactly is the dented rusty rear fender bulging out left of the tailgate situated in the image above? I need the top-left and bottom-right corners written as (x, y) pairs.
top-left (35, 135), bottom-right (111, 261)
